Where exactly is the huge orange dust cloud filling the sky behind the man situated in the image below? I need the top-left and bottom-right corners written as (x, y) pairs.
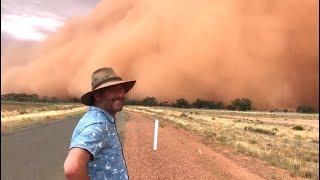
top-left (1, 0), bottom-right (319, 109)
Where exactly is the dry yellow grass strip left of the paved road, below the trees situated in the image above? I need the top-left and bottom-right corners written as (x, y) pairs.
top-left (1, 102), bottom-right (86, 133)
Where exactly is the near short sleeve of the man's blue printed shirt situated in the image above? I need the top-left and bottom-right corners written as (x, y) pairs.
top-left (69, 123), bottom-right (106, 158)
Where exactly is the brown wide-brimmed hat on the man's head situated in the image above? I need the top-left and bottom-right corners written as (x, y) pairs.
top-left (81, 67), bottom-right (136, 106)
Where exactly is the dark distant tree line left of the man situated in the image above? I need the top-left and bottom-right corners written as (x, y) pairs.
top-left (1, 93), bottom-right (81, 103)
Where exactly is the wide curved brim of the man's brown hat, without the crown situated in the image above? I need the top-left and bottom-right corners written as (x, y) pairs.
top-left (81, 81), bottom-right (136, 106)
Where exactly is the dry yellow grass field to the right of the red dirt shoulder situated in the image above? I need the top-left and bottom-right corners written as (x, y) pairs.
top-left (125, 106), bottom-right (319, 179)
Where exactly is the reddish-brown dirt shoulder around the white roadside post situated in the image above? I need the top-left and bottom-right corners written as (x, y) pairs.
top-left (123, 112), bottom-right (302, 179)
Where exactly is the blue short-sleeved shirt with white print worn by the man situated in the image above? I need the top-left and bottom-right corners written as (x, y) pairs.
top-left (69, 106), bottom-right (128, 180)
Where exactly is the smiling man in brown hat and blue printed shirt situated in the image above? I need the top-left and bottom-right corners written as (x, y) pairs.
top-left (64, 68), bottom-right (136, 180)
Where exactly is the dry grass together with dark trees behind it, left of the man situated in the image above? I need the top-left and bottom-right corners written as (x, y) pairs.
top-left (1, 93), bottom-right (86, 134)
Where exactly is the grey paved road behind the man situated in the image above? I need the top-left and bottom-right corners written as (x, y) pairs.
top-left (1, 113), bottom-right (127, 180)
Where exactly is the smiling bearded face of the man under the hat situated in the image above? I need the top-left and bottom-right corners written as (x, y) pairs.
top-left (95, 85), bottom-right (125, 113)
